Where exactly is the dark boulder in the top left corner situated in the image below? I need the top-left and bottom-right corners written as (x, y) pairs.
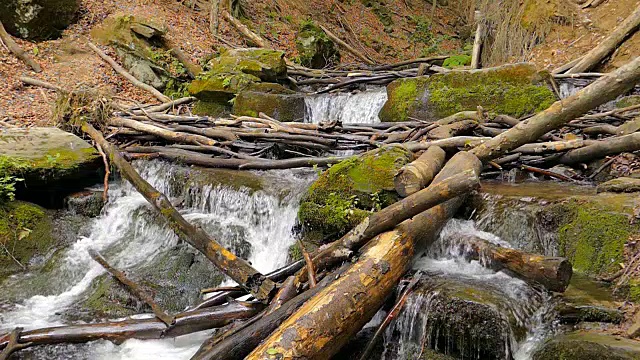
top-left (0, 0), bottom-right (80, 40)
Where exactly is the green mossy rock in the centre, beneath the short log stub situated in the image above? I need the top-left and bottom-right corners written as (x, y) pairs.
top-left (298, 146), bottom-right (413, 242)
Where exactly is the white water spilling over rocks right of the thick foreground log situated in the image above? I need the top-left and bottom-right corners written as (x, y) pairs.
top-left (382, 219), bottom-right (551, 360)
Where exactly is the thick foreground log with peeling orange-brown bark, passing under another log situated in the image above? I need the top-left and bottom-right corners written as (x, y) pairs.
top-left (246, 152), bottom-right (481, 360)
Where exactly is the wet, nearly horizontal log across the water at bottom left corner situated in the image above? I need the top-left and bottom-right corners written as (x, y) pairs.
top-left (0, 301), bottom-right (264, 349)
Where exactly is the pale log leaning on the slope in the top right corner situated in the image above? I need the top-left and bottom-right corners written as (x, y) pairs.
top-left (567, 6), bottom-right (640, 74)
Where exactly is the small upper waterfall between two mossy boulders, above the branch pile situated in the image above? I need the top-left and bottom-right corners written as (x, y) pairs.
top-left (304, 87), bottom-right (387, 124)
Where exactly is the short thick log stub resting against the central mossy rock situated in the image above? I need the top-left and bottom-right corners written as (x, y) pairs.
top-left (393, 146), bottom-right (447, 197)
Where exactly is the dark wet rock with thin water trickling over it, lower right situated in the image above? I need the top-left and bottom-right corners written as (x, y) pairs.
top-left (385, 274), bottom-right (526, 359)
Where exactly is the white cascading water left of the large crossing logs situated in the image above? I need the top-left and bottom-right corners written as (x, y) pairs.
top-left (0, 161), bottom-right (314, 359)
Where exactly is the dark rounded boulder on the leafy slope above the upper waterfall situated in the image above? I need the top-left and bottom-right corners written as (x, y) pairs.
top-left (296, 21), bottom-right (340, 69)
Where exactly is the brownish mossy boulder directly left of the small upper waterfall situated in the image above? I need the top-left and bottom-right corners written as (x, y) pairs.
top-left (233, 83), bottom-right (305, 121)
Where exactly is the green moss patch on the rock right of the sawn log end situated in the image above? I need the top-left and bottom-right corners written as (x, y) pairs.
top-left (558, 200), bottom-right (639, 275)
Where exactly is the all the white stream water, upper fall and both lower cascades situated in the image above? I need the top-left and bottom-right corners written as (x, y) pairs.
top-left (0, 88), bottom-right (551, 360)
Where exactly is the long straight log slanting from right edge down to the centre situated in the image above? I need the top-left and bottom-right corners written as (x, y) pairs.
top-left (471, 56), bottom-right (640, 162)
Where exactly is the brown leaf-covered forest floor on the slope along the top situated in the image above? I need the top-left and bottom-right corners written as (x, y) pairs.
top-left (0, 0), bottom-right (640, 126)
